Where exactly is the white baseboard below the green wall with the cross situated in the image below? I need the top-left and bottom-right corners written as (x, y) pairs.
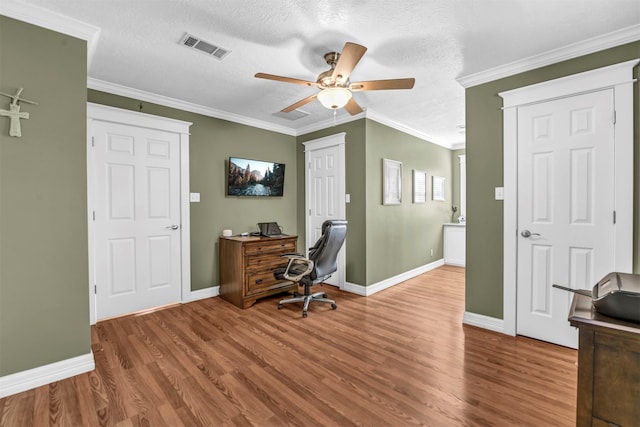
top-left (0, 353), bottom-right (96, 398)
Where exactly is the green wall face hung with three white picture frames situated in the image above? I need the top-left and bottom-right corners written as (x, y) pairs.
top-left (366, 120), bottom-right (452, 285)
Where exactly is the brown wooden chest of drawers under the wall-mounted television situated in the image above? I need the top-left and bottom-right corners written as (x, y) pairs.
top-left (220, 236), bottom-right (298, 308)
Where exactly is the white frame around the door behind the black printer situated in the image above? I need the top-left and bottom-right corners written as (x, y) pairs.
top-left (498, 59), bottom-right (640, 335)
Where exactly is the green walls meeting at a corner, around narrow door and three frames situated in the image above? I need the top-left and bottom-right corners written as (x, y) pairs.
top-left (298, 119), bottom-right (452, 286)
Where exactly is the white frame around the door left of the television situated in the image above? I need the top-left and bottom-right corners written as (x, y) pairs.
top-left (87, 102), bottom-right (192, 325)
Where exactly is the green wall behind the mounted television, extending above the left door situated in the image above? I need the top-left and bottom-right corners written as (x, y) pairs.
top-left (88, 90), bottom-right (298, 291)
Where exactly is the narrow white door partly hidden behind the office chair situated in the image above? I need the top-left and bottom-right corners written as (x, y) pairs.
top-left (305, 134), bottom-right (348, 288)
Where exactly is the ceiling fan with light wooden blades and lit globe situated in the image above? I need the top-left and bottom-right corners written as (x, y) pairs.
top-left (255, 42), bottom-right (416, 115)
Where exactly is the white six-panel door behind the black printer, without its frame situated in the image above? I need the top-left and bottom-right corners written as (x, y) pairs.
top-left (517, 90), bottom-right (615, 348)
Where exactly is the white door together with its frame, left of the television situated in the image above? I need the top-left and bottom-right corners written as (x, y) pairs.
top-left (87, 104), bottom-right (190, 323)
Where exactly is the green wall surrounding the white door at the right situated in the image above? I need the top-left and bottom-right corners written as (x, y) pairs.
top-left (465, 42), bottom-right (640, 319)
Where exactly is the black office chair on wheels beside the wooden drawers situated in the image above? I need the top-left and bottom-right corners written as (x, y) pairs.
top-left (274, 220), bottom-right (347, 317)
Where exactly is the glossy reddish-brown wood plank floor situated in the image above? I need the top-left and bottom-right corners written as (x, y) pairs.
top-left (0, 266), bottom-right (577, 426)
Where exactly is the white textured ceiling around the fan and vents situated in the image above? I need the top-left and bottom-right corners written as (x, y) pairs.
top-left (5, 0), bottom-right (640, 146)
